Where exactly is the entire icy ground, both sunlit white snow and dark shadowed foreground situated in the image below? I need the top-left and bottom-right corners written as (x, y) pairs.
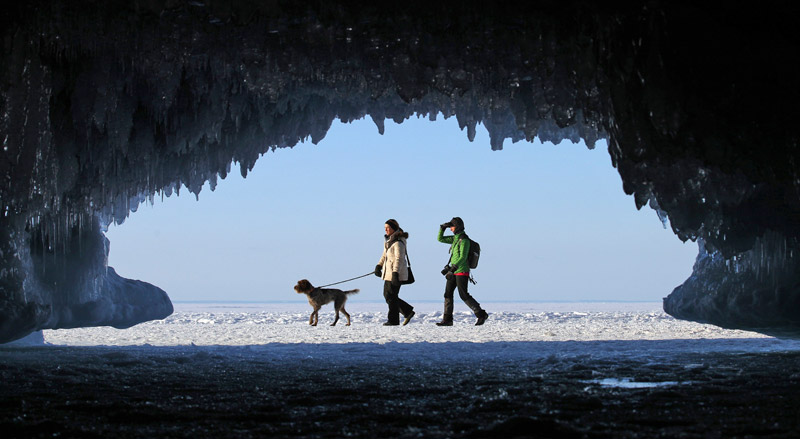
top-left (6, 301), bottom-right (800, 439)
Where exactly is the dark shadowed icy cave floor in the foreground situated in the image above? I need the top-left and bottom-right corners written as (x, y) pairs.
top-left (0, 346), bottom-right (800, 438)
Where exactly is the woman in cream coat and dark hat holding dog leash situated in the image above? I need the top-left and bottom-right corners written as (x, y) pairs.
top-left (375, 219), bottom-right (415, 326)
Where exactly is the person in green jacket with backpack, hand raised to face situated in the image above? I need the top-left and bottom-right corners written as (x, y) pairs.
top-left (436, 217), bottom-right (489, 326)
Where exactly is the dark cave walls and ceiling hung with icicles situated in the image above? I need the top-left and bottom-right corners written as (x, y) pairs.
top-left (0, 0), bottom-right (800, 342)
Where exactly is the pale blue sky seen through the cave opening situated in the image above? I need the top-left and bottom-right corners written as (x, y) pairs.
top-left (107, 117), bottom-right (697, 305)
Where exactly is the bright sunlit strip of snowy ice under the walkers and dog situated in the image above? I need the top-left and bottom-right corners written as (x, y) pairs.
top-left (44, 301), bottom-right (800, 350)
